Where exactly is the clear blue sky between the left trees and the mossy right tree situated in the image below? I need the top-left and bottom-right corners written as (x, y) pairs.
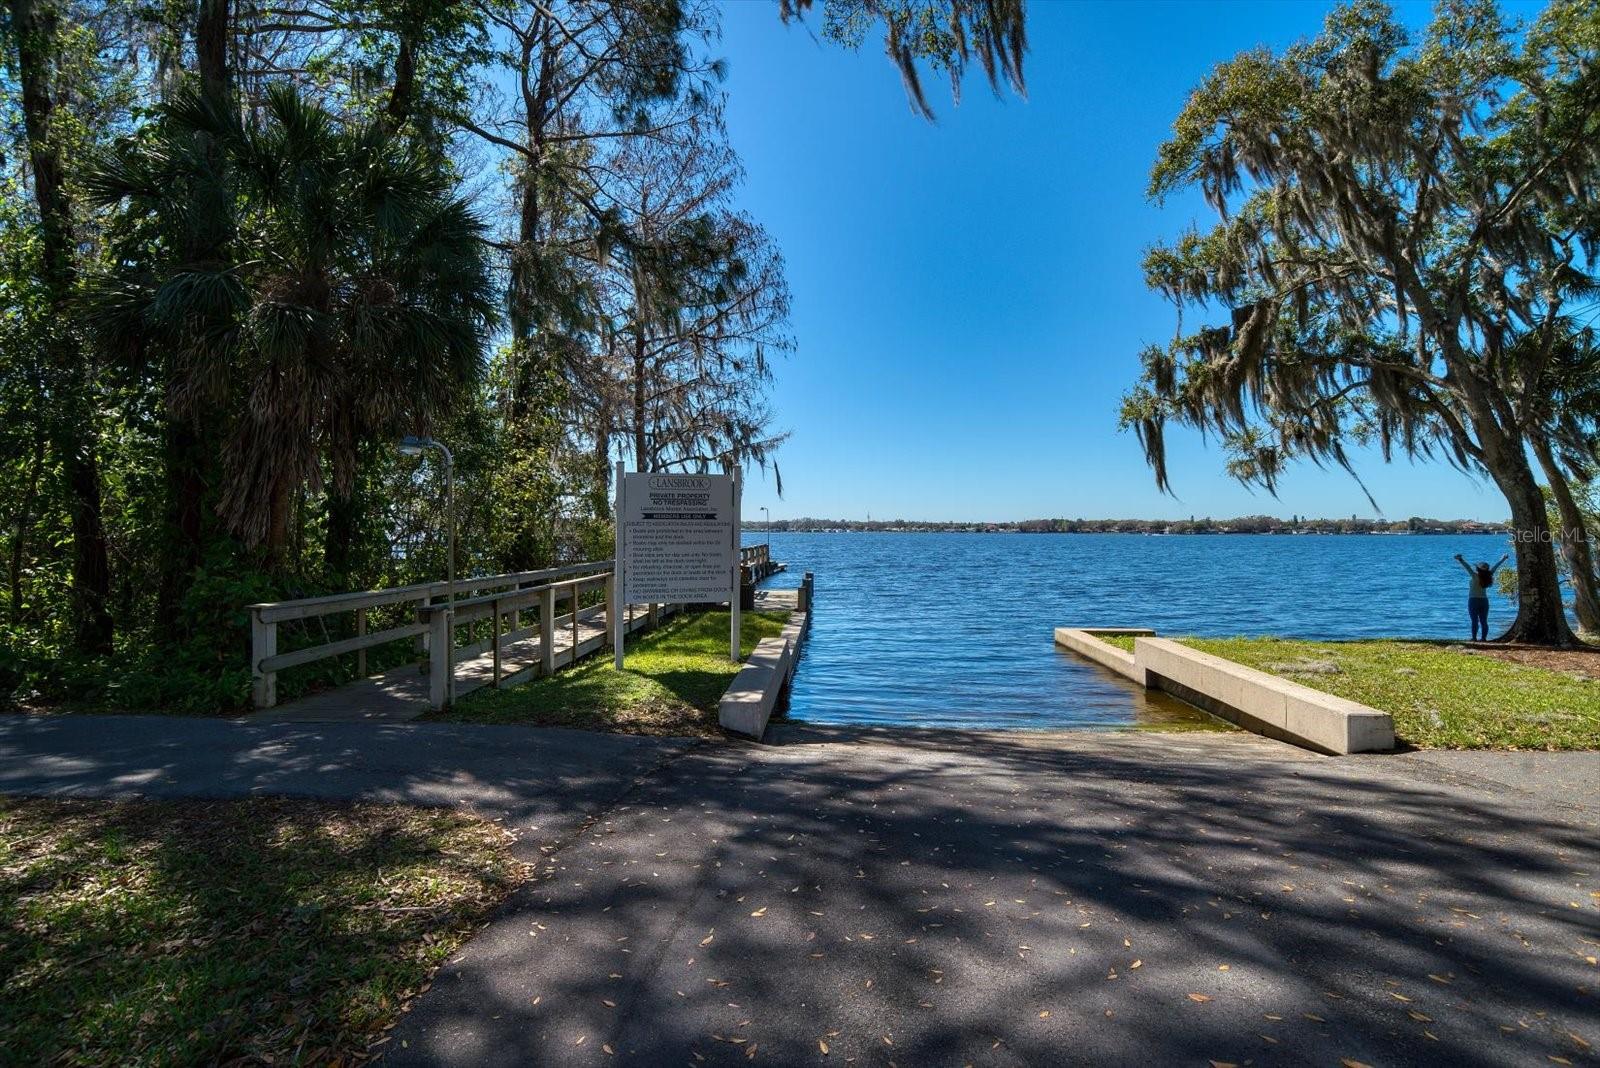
top-left (722, 0), bottom-right (1536, 520)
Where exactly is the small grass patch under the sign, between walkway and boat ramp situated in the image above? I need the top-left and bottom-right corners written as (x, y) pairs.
top-left (432, 612), bottom-right (789, 737)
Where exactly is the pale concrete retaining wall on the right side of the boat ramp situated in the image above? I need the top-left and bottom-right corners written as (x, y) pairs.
top-left (1056, 627), bottom-right (1395, 756)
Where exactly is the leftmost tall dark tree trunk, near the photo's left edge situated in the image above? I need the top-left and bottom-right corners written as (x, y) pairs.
top-left (10, 0), bottom-right (112, 654)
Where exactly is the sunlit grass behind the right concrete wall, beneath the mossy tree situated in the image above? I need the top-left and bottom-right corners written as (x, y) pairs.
top-left (1101, 635), bottom-right (1600, 750)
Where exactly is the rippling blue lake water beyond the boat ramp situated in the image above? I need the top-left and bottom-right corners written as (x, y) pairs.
top-left (746, 532), bottom-right (1515, 729)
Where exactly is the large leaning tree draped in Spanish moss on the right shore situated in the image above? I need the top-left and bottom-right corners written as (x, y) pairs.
top-left (1122, 0), bottom-right (1600, 643)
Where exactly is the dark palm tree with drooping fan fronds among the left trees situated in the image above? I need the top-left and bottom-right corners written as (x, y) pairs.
top-left (86, 86), bottom-right (494, 566)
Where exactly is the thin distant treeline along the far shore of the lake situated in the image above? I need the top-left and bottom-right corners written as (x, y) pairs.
top-left (744, 515), bottom-right (1510, 534)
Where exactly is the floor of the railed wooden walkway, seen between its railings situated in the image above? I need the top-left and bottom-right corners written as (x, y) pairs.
top-left (259, 608), bottom-right (650, 723)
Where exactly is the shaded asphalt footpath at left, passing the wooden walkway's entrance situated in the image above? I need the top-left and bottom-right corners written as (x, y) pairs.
top-left (0, 715), bottom-right (696, 857)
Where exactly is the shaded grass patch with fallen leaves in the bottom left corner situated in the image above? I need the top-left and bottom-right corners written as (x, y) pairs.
top-left (0, 799), bottom-right (523, 1065)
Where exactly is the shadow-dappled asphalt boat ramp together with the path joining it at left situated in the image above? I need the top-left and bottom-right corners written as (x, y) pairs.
top-left (0, 719), bottom-right (1600, 1066)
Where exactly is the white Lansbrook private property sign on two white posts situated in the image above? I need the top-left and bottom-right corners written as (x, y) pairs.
top-left (614, 464), bottom-right (741, 667)
